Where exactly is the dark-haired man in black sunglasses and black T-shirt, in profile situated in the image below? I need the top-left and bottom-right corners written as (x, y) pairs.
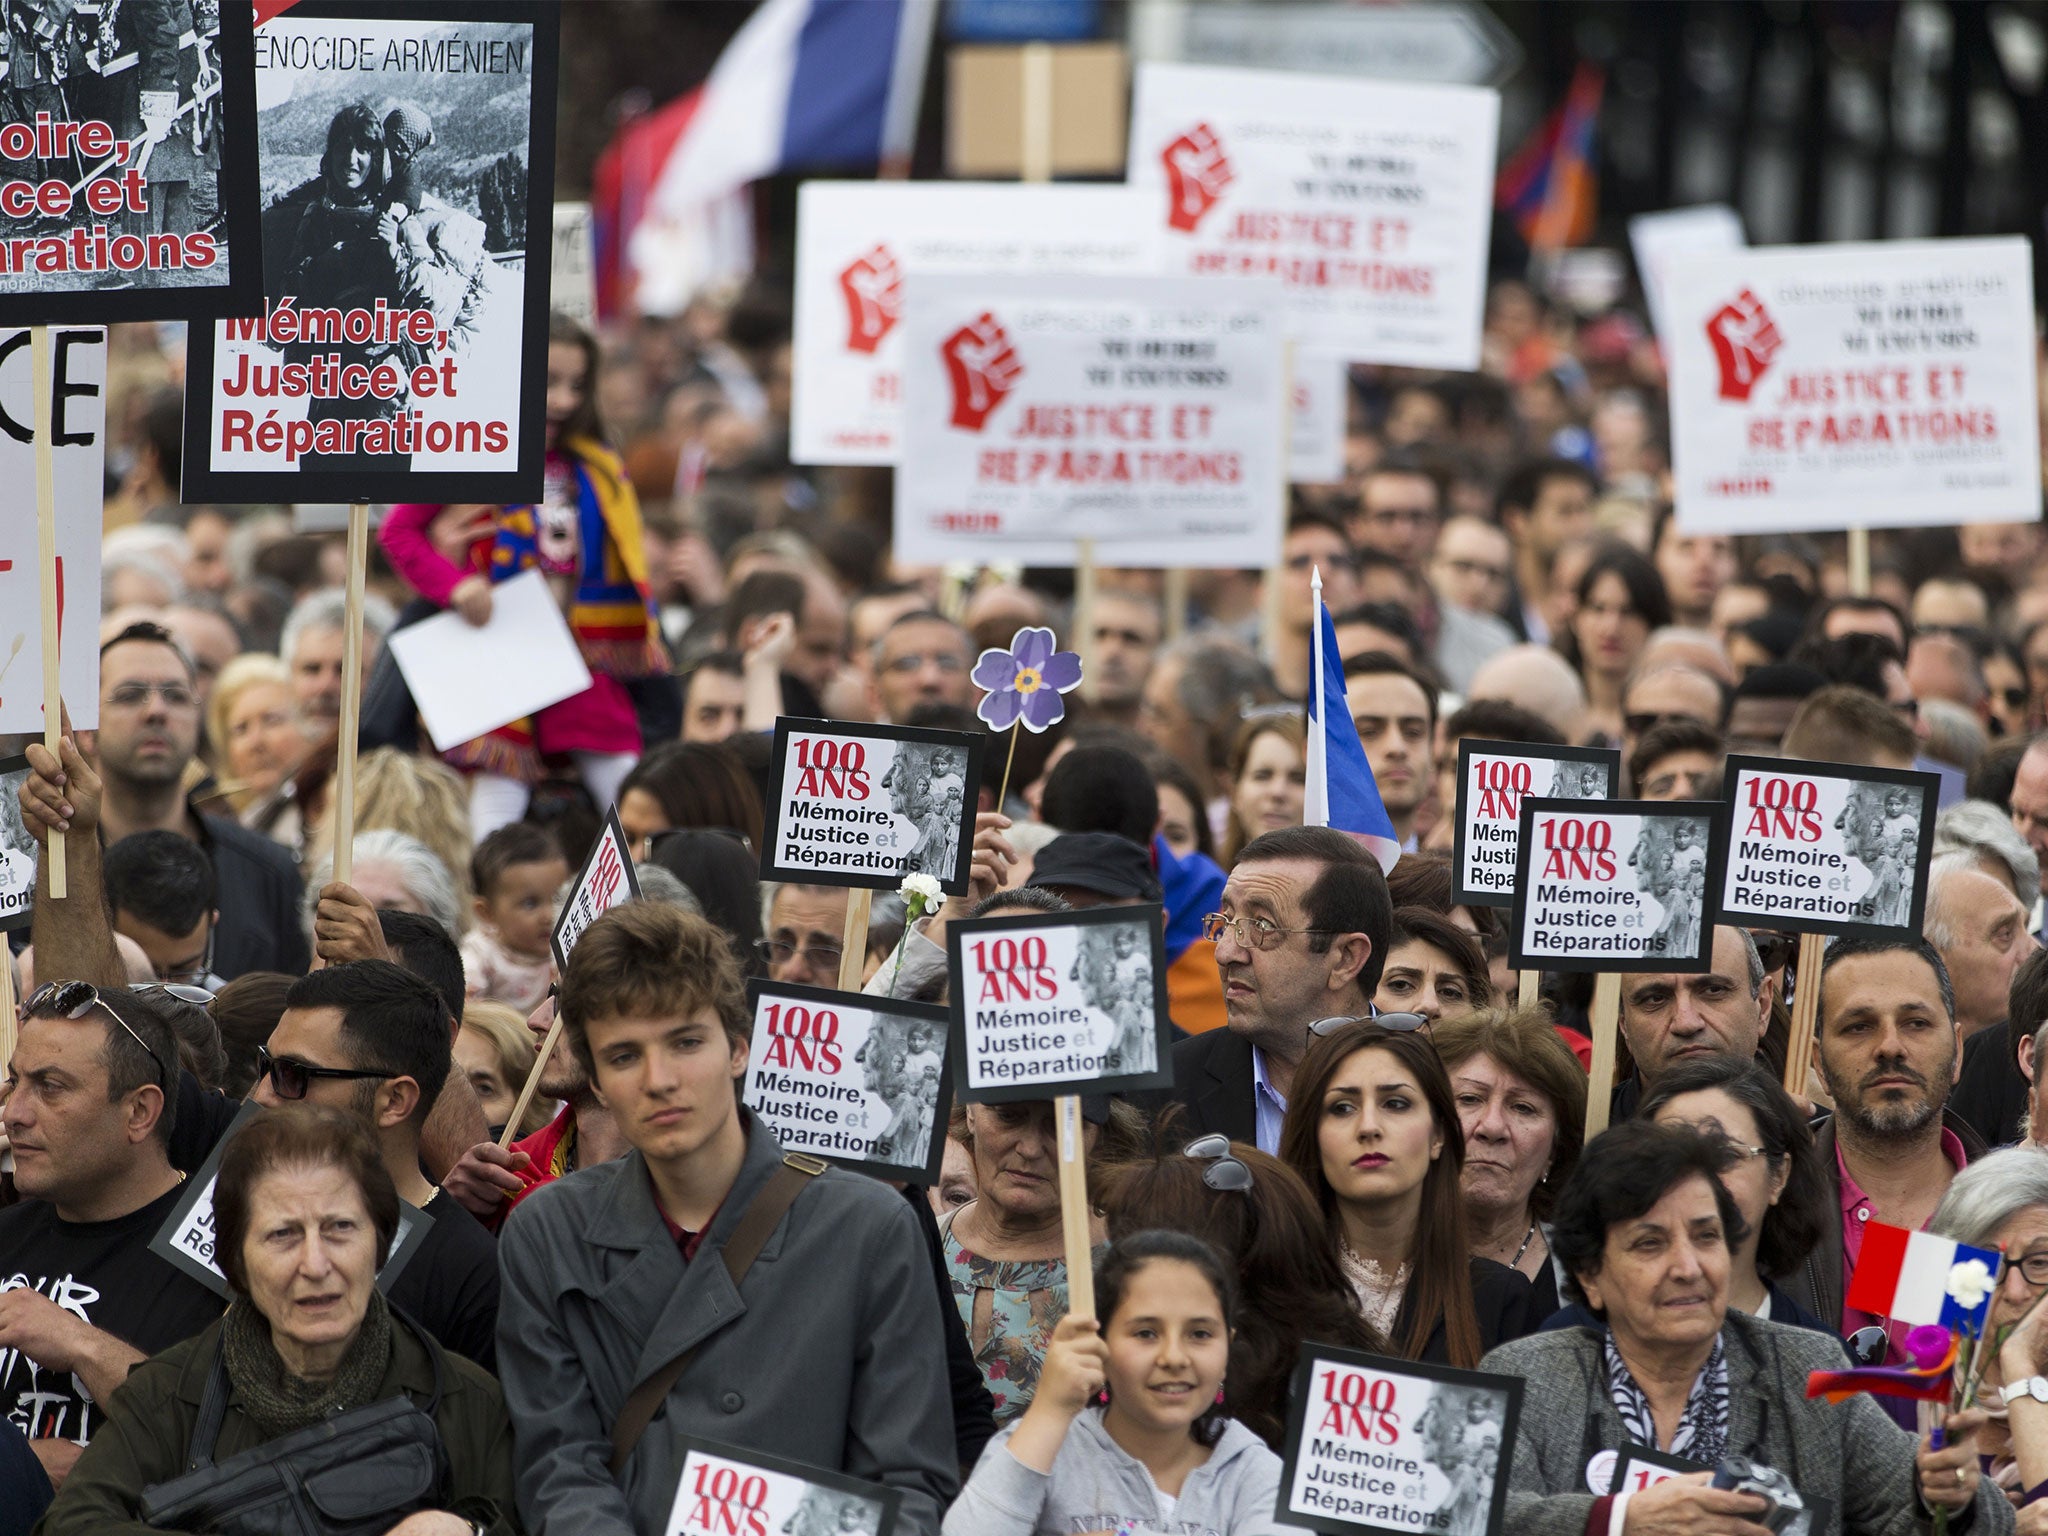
top-left (250, 961), bottom-right (498, 1370)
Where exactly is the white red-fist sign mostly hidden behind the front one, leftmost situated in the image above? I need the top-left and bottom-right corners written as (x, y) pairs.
top-left (791, 182), bottom-right (1161, 465)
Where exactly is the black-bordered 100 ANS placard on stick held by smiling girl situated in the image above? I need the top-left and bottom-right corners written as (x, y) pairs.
top-left (946, 903), bottom-right (1174, 1104)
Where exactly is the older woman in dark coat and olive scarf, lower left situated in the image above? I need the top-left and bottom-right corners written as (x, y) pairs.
top-left (37, 1106), bottom-right (518, 1536)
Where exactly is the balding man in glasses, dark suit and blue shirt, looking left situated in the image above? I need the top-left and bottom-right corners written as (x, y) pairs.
top-left (1163, 827), bottom-right (1393, 1153)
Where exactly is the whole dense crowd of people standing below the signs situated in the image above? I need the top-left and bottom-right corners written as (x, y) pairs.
top-left (0, 268), bottom-right (2048, 1536)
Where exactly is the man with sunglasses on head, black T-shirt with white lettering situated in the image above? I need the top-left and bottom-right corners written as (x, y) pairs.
top-left (0, 981), bottom-right (221, 1483)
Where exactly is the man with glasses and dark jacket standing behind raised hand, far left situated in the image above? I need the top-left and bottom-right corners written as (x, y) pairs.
top-left (83, 623), bottom-right (313, 979)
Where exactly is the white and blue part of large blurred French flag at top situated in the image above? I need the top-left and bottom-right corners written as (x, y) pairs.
top-left (649, 0), bottom-right (938, 221)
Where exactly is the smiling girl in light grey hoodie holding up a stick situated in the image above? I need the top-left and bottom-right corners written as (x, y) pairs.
top-left (944, 1231), bottom-right (1300, 1536)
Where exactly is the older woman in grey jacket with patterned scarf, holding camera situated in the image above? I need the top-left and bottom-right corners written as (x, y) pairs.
top-left (1481, 1120), bottom-right (2013, 1536)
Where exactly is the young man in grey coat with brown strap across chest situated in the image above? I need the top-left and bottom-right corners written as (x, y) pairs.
top-left (498, 901), bottom-right (958, 1536)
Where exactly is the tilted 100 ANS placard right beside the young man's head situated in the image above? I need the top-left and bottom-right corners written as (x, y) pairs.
top-left (739, 978), bottom-right (952, 1184)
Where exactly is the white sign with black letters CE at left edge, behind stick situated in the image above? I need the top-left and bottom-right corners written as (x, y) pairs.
top-left (0, 326), bottom-right (106, 735)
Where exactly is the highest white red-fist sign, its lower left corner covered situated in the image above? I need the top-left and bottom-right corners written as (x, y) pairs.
top-left (1128, 63), bottom-right (1501, 371)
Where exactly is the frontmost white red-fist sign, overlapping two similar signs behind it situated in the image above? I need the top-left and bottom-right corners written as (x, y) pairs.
top-left (895, 276), bottom-right (1290, 567)
